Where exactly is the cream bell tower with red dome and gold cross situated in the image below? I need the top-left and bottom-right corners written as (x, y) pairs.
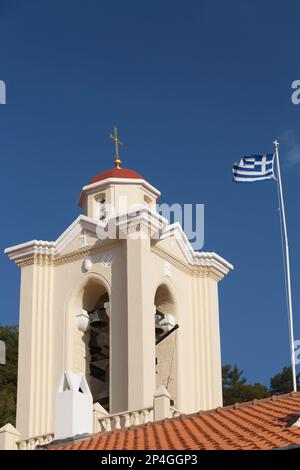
top-left (5, 132), bottom-right (232, 437)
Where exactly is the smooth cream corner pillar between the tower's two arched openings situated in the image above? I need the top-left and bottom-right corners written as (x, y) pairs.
top-left (125, 223), bottom-right (155, 410)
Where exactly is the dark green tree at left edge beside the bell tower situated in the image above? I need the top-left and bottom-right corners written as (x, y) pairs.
top-left (0, 325), bottom-right (18, 427)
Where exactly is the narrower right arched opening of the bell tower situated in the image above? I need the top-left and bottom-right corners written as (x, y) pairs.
top-left (154, 284), bottom-right (178, 403)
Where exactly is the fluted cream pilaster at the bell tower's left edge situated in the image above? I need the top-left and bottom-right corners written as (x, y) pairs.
top-left (16, 253), bottom-right (54, 438)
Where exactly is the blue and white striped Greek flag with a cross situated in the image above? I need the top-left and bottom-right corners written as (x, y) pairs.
top-left (232, 154), bottom-right (276, 183)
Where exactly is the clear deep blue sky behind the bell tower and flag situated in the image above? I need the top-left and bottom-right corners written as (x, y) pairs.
top-left (0, 0), bottom-right (300, 383)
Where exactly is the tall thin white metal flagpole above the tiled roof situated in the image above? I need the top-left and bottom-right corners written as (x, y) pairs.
top-left (273, 140), bottom-right (297, 392)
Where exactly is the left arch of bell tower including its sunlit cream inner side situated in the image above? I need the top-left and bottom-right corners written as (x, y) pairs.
top-left (63, 272), bottom-right (111, 411)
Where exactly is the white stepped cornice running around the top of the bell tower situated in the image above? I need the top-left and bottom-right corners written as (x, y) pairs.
top-left (5, 206), bottom-right (233, 279)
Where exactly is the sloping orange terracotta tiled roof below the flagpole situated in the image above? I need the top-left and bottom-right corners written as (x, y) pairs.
top-left (51, 392), bottom-right (300, 450)
